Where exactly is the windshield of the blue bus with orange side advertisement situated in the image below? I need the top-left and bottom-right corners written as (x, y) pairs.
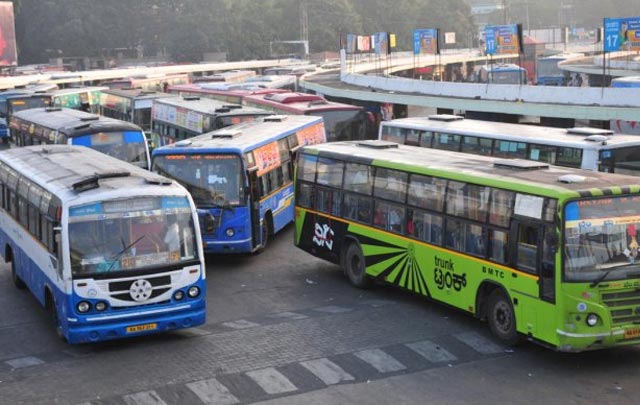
top-left (153, 154), bottom-right (245, 208)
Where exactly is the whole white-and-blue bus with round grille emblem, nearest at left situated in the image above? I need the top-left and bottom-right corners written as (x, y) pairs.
top-left (0, 145), bottom-right (206, 343)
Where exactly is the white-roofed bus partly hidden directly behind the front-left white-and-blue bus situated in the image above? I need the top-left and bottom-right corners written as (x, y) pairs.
top-left (9, 108), bottom-right (150, 170)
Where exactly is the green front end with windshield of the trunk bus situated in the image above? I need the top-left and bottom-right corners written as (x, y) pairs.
top-left (558, 194), bottom-right (640, 350)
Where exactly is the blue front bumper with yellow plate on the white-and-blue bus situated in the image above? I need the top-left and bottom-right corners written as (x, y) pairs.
top-left (65, 298), bottom-right (206, 344)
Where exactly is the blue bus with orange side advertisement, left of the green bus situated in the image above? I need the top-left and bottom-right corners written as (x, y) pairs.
top-left (152, 115), bottom-right (326, 254)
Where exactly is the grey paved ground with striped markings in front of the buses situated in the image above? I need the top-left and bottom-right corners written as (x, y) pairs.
top-left (0, 228), bottom-right (640, 405)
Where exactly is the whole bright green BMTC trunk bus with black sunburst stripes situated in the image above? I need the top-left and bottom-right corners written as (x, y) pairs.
top-left (295, 140), bottom-right (640, 352)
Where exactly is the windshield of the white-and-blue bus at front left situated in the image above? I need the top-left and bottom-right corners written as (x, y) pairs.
top-left (69, 197), bottom-right (197, 278)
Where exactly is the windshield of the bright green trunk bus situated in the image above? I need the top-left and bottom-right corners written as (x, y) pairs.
top-left (564, 196), bottom-right (640, 282)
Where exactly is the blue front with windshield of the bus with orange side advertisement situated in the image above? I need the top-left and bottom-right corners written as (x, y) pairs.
top-left (153, 150), bottom-right (253, 253)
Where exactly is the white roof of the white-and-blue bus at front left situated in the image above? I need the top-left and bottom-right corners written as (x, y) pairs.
top-left (0, 145), bottom-right (186, 201)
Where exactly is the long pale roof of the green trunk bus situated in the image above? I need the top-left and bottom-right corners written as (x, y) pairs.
top-left (301, 140), bottom-right (640, 197)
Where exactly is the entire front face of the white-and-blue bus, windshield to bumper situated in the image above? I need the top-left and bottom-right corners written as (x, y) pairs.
top-left (61, 195), bottom-right (206, 343)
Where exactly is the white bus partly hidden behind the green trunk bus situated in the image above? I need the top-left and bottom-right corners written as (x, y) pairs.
top-left (378, 114), bottom-right (640, 175)
